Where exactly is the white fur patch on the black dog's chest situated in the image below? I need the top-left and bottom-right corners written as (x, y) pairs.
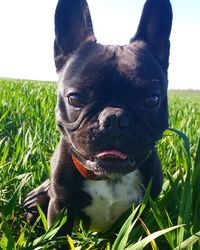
top-left (82, 170), bottom-right (143, 231)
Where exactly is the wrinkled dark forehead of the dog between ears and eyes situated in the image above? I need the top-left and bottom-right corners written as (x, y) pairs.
top-left (60, 42), bottom-right (167, 91)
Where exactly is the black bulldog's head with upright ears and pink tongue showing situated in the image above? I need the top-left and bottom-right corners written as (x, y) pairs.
top-left (54, 0), bottom-right (172, 178)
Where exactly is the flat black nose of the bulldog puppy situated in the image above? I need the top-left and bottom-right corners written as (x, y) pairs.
top-left (99, 107), bottom-right (130, 131)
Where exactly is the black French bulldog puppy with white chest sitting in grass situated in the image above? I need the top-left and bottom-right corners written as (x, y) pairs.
top-left (24, 0), bottom-right (172, 246)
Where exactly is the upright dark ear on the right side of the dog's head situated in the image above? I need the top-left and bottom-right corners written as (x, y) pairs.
top-left (131, 0), bottom-right (172, 70)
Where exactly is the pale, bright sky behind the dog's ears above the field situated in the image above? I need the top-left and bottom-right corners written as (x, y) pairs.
top-left (0, 0), bottom-right (200, 89)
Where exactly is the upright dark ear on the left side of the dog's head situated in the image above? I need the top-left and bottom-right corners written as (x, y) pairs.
top-left (54, 0), bottom-right (96, 71)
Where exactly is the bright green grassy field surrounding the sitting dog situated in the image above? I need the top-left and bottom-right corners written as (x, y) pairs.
top-left (0, 79), bottom-right (200, 250)
